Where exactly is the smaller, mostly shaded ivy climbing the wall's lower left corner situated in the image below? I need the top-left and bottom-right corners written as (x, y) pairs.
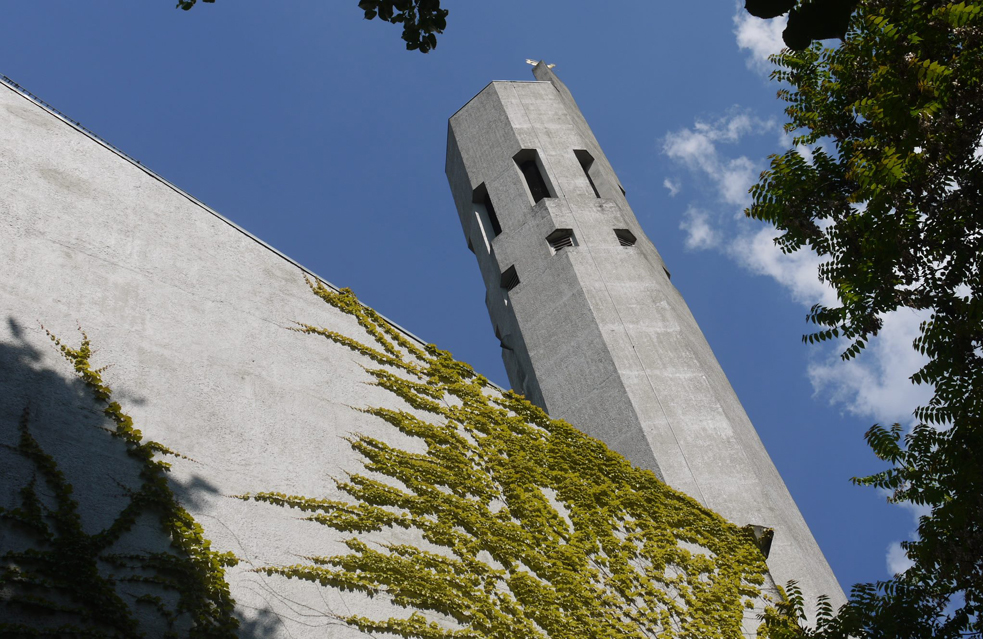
top-left (0, 333), bottom-right (238, 638)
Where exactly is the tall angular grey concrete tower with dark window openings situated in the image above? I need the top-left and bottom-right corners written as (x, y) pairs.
top-left (446, 62), bottom-right (845, 616)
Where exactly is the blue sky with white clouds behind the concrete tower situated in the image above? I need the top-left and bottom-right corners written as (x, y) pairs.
top-left (0, 0), bottom-right (925, 588)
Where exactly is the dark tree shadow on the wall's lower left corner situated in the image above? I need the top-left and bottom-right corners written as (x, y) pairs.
top-left (0, 318), bottom-right (277, 637)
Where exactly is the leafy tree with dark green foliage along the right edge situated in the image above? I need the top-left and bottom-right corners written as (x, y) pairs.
top-left (747, 0), bottom-right (983, 637)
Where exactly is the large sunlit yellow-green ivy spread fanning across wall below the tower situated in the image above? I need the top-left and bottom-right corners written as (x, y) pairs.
top-left (242, 282), bottom-right (766, 639)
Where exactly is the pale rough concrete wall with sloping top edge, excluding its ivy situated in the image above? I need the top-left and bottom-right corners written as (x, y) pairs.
top-left (0, 77), bottom-right (442, 638)
